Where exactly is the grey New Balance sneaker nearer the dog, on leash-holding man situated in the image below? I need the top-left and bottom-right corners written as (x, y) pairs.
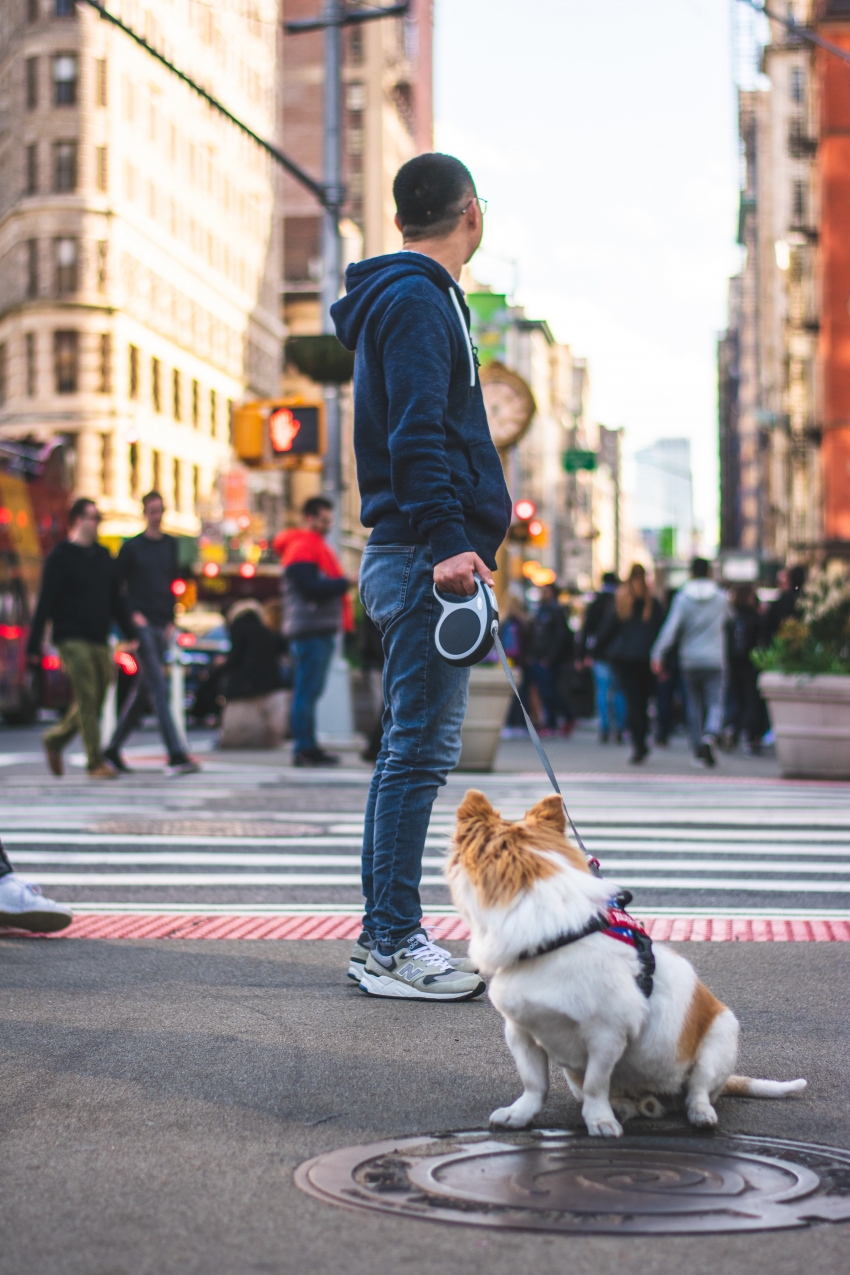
top-left (361, 929), bottom-right (486, 1001)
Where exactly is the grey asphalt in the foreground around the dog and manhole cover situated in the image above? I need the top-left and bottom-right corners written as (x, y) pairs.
top-left (0, 937), bottom-right (850, 1275)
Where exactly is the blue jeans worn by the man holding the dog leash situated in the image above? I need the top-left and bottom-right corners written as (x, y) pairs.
top-left (359, 544), bottom-right (469, 954)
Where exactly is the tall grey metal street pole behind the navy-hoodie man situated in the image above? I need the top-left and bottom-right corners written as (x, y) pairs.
top-left (321, 0), bottom-right (344, 550)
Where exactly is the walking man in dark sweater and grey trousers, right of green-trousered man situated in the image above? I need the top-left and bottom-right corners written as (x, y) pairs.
top-left (104, 491), bottom-right (200, 775)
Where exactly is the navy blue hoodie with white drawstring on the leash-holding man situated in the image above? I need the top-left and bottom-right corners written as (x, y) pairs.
top-left (331, 251), bottom-right (511, 569)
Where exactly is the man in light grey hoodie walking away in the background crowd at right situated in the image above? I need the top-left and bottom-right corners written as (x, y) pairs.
top-left (651, 558), bottom-right (729, 766)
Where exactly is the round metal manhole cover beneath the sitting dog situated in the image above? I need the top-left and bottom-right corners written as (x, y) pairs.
top-left (296, 1130), bottom-right (850, 1234)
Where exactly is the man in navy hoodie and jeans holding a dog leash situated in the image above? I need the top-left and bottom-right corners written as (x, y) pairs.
top-left (331, 154), bottom-right (511, 1001)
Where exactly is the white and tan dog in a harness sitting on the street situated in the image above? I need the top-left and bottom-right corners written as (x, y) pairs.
top-left (446, 789), bottom-right (805, 1137)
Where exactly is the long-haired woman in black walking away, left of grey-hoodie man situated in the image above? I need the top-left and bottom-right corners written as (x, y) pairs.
top-left (599, 562), bottom-right (663, 765)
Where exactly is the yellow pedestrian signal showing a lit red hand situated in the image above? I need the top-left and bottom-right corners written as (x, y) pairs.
top-left (233, 399), bottom-right (325, 469)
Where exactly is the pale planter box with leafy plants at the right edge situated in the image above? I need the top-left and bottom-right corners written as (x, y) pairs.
top-left (758, 673), bottom-right (850, 779)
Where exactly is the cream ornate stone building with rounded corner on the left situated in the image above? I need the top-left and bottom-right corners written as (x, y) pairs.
top-left (0, 0), bottom-right (283, 537)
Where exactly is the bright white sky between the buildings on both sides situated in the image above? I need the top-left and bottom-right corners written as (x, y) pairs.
top-left (435, 0), bottom-right (740, 550)
